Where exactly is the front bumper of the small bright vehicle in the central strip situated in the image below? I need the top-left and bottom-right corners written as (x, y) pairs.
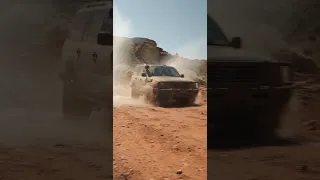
top-left (153, 88), bottom-right (199, 99)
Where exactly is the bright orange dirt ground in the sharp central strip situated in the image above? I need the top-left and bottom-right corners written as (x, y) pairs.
top-left (113, 87), bottom-right (207, 180)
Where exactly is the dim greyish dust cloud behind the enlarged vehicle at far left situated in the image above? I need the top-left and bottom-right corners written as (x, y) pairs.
top-left (0, 1), bottom-right (109, 146)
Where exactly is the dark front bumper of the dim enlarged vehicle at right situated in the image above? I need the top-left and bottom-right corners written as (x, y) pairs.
top-left (207, 85), bottom-right (292, 114)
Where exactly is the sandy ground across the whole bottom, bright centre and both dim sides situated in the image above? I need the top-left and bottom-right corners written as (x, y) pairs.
top-left (0, 66), bottom-right (320, 180)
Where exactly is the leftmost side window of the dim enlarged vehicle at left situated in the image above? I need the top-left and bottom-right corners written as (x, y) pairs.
top-left (69, 11), bottom-right (92, 41)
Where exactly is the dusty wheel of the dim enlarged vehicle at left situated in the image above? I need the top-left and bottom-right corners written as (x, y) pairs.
top-left (62, 85), bottom-right (92, 118)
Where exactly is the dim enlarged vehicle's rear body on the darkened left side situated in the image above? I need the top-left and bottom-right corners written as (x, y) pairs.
top-left (60, 1), bottom-right (113, 117)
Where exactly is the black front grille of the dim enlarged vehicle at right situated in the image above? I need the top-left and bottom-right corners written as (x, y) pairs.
top-left (208, 63), bottom-right (260, 83)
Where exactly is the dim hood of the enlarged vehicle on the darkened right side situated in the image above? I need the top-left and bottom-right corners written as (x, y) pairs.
top-left (207, 46), bottom-right (279, 63)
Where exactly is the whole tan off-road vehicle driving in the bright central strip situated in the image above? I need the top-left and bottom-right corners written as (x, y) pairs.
top-left (130, 65), bottom-right (199, 106)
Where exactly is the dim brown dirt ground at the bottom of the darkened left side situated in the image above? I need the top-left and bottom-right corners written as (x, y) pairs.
top-left (0, 109), bottom-right (112, 180)
